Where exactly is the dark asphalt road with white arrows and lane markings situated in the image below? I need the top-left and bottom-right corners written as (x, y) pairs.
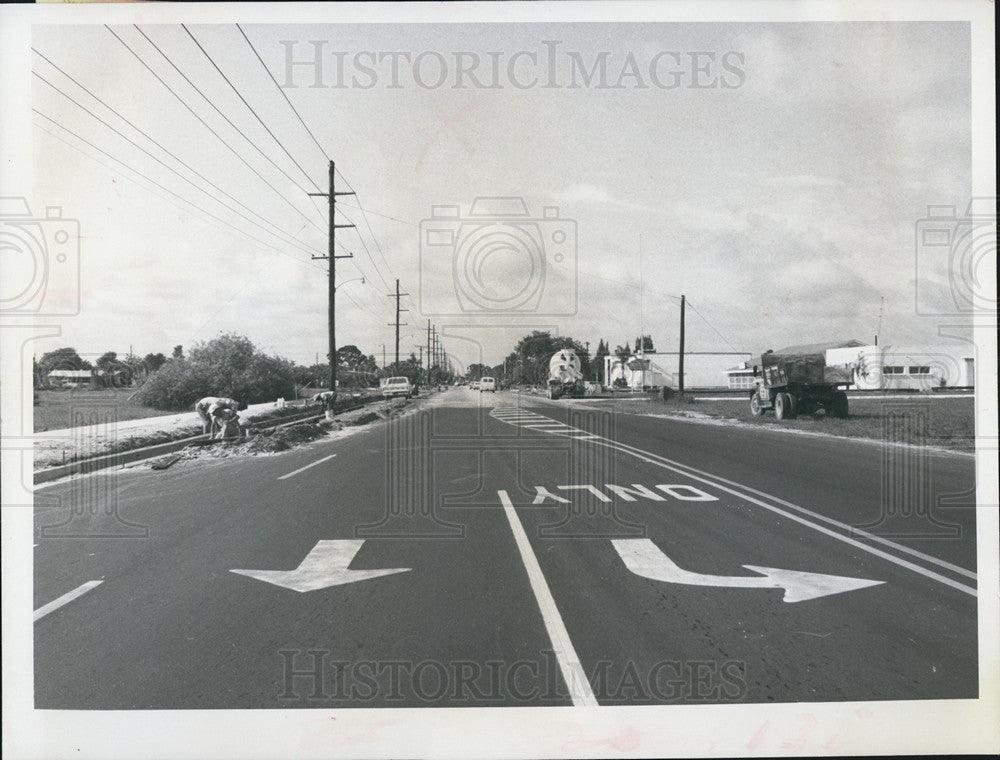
top-left (34, 388), bottom-right (978, 709)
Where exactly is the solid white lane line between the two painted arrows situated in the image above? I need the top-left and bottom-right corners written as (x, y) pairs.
top-left (497, 491), bottom-right (598, 707)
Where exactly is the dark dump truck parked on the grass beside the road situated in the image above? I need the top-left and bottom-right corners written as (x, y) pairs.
top-left (750, 351), bottom-right (854, 420)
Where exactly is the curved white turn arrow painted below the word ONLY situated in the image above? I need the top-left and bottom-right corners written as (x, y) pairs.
top-left (611, 538), bottom-right (885, 602)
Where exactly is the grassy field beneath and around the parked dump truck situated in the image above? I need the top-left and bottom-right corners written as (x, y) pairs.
top-left (594, 394), bottom-right (975, 451)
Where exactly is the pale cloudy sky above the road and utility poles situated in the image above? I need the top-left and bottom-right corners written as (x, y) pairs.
top-left (19, 17), bottom-right (973, 368)
